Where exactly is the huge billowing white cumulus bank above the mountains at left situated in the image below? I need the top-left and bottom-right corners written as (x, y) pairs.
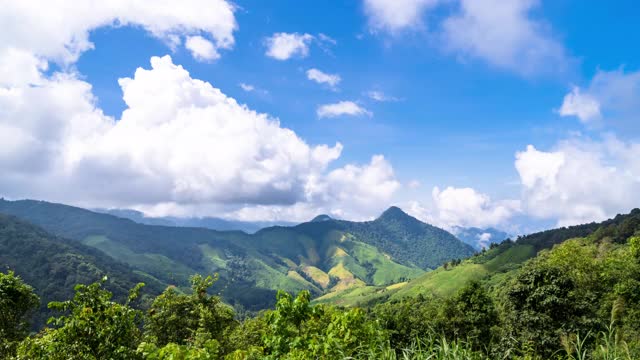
top-left (0, 52), bottom-right (399, 216)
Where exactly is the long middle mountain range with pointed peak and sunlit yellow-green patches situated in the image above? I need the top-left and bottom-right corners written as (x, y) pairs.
top-left (0, 200), bottom-right (474, 310)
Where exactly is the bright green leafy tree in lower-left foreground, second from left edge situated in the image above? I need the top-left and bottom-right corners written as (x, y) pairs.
top-left (17, 278), bottom-right (144, 359)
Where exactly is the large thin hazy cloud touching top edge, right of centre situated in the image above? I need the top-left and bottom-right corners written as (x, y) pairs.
top-left (443, 0), bottom-right (569, 75)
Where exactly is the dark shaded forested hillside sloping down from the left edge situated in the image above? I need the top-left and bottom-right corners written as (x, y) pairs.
top-left (0, 214), bottom-right (166, 328)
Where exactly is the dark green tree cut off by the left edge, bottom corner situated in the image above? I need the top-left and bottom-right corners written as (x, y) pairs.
top-left (0, 271), bottom-right (40, 358)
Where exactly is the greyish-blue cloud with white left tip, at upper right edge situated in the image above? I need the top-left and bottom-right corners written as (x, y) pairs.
top-left (559, 69), bottom-right (640, 123)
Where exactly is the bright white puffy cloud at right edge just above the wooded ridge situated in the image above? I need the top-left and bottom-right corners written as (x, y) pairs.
top-left (515, 136), bottom-right (640, 226)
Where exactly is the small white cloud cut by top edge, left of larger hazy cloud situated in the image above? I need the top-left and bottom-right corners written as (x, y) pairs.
top-left (364, 0), bottom-right (440, 33)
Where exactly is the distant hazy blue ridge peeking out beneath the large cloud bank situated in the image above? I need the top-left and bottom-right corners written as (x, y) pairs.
top-left (94, 209), bottom-right (296, 234)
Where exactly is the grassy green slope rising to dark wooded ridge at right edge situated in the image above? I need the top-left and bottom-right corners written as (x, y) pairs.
top-left (315, 209), bottom-right (640, 306)
